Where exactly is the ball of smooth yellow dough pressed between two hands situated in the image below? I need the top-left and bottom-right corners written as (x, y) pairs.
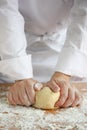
top-left (34, 87), bottom-right (60, 109)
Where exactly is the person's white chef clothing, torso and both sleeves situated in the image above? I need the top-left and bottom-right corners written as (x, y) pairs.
top-left (0, 0), bottom-right (87, 82)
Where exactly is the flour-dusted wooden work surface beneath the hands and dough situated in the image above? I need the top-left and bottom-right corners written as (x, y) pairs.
top-left (0, 84), bottom-right (87, 130)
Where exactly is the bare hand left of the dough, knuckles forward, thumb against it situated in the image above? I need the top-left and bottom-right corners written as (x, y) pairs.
top-left (8, 79), bottom-right (42, 106)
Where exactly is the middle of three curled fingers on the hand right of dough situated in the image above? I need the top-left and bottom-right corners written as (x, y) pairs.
top-left (62, 87), bottom-right (75, 108)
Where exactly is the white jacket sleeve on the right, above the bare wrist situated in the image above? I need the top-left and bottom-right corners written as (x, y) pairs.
top-left (55, 0), bottom-right (87, 78)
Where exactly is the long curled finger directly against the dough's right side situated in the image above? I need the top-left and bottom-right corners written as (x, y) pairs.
top-left (55, 81), bottom-right (68, 107)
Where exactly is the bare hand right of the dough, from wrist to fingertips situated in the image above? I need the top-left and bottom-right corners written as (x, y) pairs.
top-left (46, 72), bottom-right (82, 108)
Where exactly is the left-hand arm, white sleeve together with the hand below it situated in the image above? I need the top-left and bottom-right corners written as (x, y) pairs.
top-left (0, 0), bottom-right (39, 106)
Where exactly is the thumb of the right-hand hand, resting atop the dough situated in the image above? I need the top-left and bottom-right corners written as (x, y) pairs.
top-left (47, 80), bottom-right (60, 92)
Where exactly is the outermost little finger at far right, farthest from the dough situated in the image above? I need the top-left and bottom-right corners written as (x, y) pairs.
top-left (72, 90), bottom-right (82, 107)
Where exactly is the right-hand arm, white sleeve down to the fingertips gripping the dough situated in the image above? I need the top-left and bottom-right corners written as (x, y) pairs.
top-left (47, 0), bottom-right (87, 107)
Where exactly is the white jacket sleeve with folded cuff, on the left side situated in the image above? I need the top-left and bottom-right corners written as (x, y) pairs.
top-left (0, 0), bottom-right (33, 80)
